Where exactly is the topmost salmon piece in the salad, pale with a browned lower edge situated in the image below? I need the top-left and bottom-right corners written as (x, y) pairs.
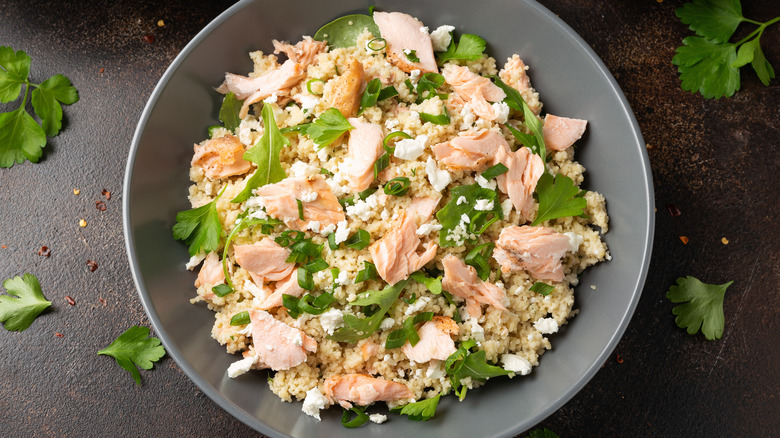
top-left (374, 12), bottom-right (439, 73)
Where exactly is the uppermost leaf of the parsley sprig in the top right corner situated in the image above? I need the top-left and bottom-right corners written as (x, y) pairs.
top-left (674, 0), bottom-right (745, 43)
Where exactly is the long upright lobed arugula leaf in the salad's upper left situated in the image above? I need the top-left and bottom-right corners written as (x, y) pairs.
top-left (235, 104), bottom-right (290, 202)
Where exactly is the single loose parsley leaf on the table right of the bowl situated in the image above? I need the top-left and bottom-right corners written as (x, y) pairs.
top-left (666, 276), bottom-right (734, 341)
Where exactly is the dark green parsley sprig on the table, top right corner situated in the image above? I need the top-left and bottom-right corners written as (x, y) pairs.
top-left (672, 0), bottom-right (780, 99)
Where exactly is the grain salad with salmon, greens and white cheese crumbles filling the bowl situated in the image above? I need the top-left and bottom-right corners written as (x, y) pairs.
top-left (173, 11), bottom-right (610, 427)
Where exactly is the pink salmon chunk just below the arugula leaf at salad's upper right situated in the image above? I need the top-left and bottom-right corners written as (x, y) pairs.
top-left (441, 64), bottom-right (506, 121)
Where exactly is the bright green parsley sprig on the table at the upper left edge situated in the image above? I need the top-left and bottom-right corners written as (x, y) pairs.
top-left (0, 46), bottom-right (79, 167)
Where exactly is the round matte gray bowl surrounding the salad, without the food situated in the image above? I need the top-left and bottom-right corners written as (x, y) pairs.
top-left (124, 0), bottom-right (654, 437)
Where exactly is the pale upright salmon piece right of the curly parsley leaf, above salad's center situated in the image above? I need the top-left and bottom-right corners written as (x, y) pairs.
top-left (344, 118), bottom-right (385, 192)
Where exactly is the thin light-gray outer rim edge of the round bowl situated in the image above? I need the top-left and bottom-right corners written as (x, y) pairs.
top-left (122, 0), bottom-right (655, 436)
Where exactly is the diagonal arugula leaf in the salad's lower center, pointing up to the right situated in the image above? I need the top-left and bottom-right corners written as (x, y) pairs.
top-left (328, 279), bottom-right (409, 343)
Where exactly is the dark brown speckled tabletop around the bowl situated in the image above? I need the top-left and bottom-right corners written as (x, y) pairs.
top-left (0, 0), bottom-right (780, 437)
